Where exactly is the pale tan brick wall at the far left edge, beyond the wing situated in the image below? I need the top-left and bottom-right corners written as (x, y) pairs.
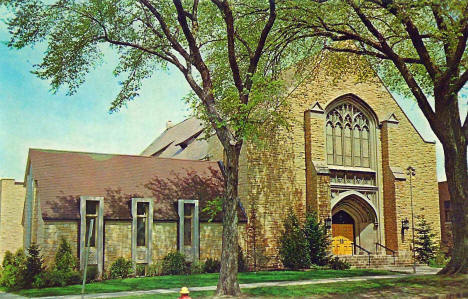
top-left (0, 179), bottom-right (26, 261)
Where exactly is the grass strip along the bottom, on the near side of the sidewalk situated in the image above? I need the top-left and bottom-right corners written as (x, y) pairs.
top-left (117, 275), bottom-right (468, 299)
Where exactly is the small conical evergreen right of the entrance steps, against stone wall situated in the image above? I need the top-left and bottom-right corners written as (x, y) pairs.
top-left (414, 217), bottom-right (437, 264)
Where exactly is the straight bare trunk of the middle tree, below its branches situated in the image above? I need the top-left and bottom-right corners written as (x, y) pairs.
top-left (216, 143), bottom-right (242, 296)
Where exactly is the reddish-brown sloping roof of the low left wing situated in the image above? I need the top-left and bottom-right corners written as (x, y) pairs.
top-left (28, 149), bottom-right (246, 221)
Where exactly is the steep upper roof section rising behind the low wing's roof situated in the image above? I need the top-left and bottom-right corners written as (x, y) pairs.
top-left (141, 117), bottom-right (208, 160)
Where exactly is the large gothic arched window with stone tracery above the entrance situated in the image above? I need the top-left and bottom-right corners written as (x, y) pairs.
top-left (325, 103), bottom-right (372, 167)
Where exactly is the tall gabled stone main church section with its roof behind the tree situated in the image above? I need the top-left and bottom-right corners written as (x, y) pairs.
top-left (142, 55), bottom-right (440, 267)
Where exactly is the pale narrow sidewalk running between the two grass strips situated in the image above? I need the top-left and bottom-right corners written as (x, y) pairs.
top-left (0, 267), bottom-right (440, 299)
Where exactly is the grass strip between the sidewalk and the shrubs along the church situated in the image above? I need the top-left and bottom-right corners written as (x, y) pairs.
top-left (15, 269), bottom-right (395, 297)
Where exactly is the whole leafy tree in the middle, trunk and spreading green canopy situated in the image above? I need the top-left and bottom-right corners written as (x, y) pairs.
top-left (0, 0), bottom-right (285, 295)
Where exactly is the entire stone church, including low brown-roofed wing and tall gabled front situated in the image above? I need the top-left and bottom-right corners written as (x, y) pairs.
top-left (0, 54), bottom-right (440, 269)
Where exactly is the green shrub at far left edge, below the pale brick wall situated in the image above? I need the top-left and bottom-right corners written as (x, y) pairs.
top-left (0, 249), bottom-right (27, 290)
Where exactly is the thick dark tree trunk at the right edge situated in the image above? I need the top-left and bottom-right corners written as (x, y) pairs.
top-left (436, 97), bottom-right (468, 274)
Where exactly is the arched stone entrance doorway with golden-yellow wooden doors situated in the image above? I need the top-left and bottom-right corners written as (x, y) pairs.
top-left (332, 191), bottom-right (378, 255)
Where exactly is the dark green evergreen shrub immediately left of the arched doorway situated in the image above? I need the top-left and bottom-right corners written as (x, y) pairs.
top-left (304, 213), bottom-right (330, 266)
